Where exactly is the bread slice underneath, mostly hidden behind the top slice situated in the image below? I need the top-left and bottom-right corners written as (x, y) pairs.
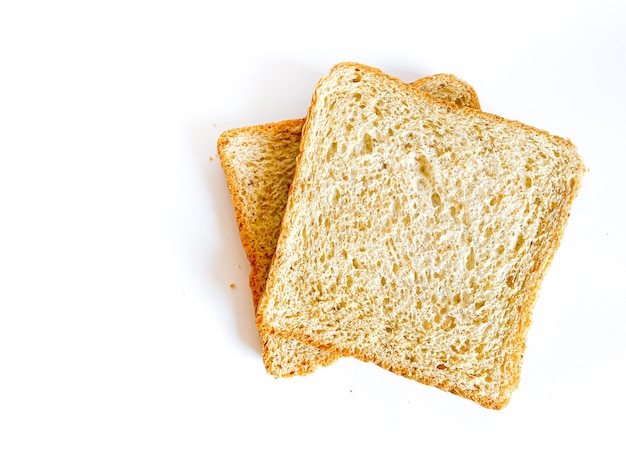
top-left (218, 74), bottom-right (480, 377)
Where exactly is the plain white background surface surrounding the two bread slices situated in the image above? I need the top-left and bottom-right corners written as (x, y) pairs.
top-left (0, 0), bottom-right (626, 469)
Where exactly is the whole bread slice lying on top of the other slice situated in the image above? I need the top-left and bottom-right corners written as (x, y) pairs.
top-left (258, 63), bottom-right (584, 409)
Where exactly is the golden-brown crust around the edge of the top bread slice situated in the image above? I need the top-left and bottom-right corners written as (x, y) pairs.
top-left (259, 62), bottom-right (585, 409)
